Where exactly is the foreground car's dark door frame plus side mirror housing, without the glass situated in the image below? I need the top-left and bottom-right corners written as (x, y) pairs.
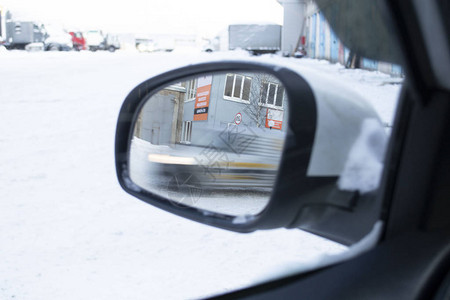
top-left (115, 0), bottom-right (450, 299)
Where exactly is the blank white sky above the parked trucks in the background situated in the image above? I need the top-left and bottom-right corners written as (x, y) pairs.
top-left (0, 0), bottom-right (283, 37)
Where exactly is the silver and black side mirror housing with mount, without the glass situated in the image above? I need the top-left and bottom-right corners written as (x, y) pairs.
top-left (115, 61), bottom-right (381, 244)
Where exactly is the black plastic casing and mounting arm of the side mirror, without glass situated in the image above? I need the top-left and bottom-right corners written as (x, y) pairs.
top-left (115, 61), bottom-right (384, 244)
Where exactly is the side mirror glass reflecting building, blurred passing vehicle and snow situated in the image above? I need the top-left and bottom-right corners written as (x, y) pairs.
top-left (129, 71), bottom-right (288, 216)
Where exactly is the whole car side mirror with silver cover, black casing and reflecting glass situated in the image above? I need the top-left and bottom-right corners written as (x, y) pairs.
top-left (116, 61), bottom-right (381, 244)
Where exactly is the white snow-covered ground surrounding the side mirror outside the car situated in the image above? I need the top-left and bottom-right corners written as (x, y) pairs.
top-left (0, 52), bottom-right (400, 300)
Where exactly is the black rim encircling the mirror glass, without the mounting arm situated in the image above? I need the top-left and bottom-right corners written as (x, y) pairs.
top-left (116, 61), bottom-right (317, 227)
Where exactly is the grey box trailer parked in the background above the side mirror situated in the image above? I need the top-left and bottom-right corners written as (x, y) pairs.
top-left (228, 24), bottom-right (281, 55)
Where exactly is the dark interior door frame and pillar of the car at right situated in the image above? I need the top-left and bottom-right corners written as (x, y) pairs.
top-left (212, 1), bottom-right (450, 299)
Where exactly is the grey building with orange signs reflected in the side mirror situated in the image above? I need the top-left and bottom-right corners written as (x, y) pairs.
top-left (135, 73), bottom-right (288, 146)
